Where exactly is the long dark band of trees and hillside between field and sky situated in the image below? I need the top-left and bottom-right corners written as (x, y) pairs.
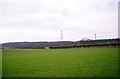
top-left (2, 38), bottom-right (120, 49)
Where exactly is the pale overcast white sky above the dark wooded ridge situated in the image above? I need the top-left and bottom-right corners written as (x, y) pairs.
top-left (0, 0), bottom-right (119, 43)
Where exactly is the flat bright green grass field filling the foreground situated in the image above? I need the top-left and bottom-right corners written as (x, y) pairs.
top-left (2, 48), bottom-right (118, 77)
